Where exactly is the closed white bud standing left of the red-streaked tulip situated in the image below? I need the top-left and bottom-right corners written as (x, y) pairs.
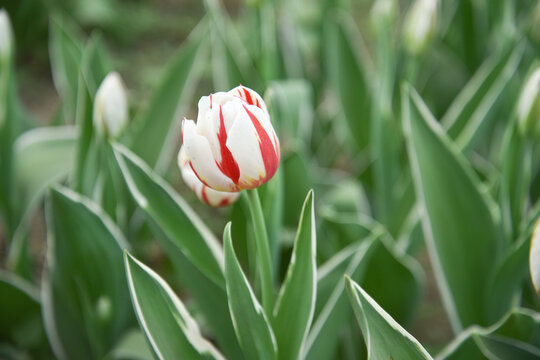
top-left (94, 72), bottom-right (128, 139)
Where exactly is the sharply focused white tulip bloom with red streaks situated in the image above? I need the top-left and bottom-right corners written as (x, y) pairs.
top-left (182, 86), bottom-right (280, 192)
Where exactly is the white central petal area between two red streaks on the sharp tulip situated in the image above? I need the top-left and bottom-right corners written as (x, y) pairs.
top-left (227, 107), bottom-right (266, 182)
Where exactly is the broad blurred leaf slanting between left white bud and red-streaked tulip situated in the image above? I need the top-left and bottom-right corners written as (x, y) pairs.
top-left (125, 23), bottom-right (207, 171)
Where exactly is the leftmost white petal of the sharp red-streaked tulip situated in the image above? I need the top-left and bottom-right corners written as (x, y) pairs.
top-left (183, 120), bottom-right (237, 191)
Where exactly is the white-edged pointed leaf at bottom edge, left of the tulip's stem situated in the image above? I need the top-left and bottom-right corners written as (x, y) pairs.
top-left (124, 252), bottom-right (224, 359)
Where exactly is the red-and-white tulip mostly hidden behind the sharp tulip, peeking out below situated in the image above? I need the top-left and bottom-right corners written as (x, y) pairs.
top-left (178, 146), bottom-right (240, 207)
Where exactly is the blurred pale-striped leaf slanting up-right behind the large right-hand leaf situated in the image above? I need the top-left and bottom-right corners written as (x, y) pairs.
top-left (441, 43), bottom-right (525, 149)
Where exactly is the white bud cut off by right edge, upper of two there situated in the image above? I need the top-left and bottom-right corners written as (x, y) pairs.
top-left (517, 67), bottom-right (540, 138)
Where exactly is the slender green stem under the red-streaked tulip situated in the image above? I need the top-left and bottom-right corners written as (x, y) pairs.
top-left (247, 189), bottom-right (274, 317)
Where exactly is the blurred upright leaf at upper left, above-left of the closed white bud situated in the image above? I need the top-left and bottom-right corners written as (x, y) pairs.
top-left (49, 17), bottom-right (83, 119)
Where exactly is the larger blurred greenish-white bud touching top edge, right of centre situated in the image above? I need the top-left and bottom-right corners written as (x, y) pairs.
top-left (404, 0), bottom-right (439, 56)
